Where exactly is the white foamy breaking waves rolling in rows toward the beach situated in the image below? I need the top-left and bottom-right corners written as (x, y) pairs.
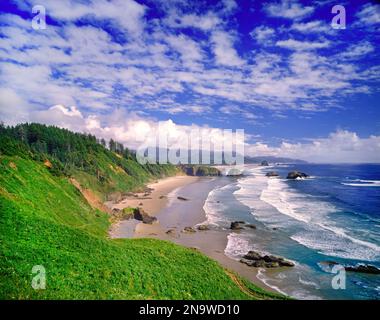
top-left (234, 168), bottom-right (380, 261)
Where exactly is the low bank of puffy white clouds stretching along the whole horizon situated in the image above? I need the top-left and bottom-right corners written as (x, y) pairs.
top-left (27, 105), bottom-right (380, 163)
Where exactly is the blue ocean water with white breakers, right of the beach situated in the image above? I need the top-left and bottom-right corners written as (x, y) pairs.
top-left (204, 164), bottom-right (380, 299)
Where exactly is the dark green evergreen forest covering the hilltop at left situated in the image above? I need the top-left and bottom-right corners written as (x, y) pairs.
top-left (0, 123), bottom-right (172, 179)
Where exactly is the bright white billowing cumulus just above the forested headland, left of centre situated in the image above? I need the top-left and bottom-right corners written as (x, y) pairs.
top-left (29, 105), bottom-right (244, 151)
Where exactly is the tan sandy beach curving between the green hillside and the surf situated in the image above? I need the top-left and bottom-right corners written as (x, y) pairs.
top-left (110, 176), bottom-right (278, 293)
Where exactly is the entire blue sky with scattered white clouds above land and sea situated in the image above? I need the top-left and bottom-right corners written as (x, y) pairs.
top-left (0, 0), bottom-right (380, 162)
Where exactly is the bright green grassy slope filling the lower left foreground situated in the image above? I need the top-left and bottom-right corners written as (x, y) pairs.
top-left (0, 156), bottom-right (280, 299)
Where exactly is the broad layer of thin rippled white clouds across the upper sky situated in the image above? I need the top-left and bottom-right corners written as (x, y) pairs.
top-left (0, 0), bottom-right (379, 132)
